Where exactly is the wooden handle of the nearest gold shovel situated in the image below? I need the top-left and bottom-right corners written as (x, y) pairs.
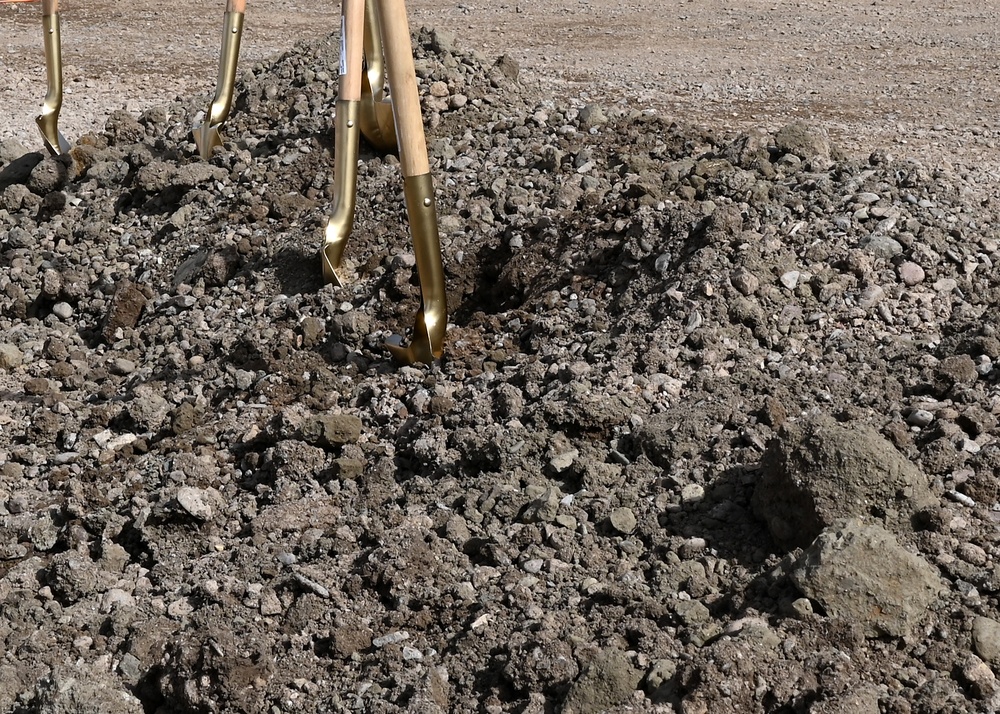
top-left (376, 0), bottom-right (430, 177)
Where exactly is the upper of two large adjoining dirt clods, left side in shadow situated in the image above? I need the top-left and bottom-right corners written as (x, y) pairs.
top-left (753, 416), bottom-right (937, 549)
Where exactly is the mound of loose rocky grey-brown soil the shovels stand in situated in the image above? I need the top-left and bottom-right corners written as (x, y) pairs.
top-left (0, 19), bottom-right (1000, 714)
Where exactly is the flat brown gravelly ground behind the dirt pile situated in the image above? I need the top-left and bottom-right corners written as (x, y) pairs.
top-left (0, 0), bottom-right (1000, 167)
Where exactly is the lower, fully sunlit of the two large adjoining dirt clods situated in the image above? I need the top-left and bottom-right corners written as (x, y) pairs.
top-left (790, 518), bottom-right (945, 637)
